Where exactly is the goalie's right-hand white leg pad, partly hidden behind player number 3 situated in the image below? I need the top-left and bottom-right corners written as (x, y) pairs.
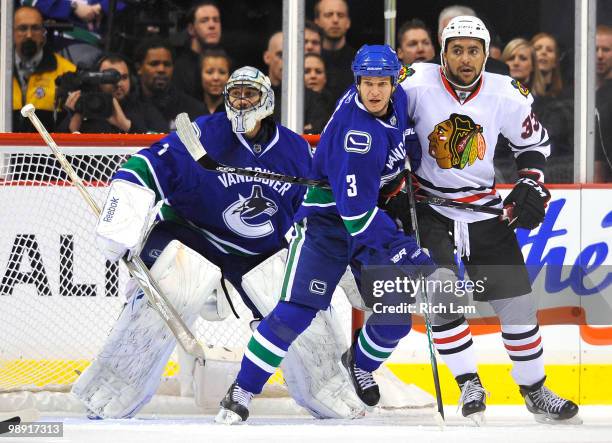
top-left (242, 250), bottom-right (365, 418)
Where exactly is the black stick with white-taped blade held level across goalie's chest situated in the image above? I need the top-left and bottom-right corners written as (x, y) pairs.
top-left (175, 112), bottom-right (509, 219)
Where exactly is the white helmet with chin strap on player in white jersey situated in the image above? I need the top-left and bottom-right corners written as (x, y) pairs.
top-left (440, 15), bottom-right (491, 88)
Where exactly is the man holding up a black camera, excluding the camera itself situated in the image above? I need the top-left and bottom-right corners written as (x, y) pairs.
top-left (59, 54), bottom-right (147, 133)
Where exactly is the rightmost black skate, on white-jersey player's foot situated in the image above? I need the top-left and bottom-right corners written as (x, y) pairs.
top-left (520, 377), bottom-right (582, 424)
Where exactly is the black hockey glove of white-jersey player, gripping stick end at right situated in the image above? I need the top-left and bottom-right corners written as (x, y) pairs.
top-left (504, 176), bottom-right (550, 229)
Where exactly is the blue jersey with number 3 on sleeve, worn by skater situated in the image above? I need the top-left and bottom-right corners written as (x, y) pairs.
top-left (296, 86), bottom-right (421, 250)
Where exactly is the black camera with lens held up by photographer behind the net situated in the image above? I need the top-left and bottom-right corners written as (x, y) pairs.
top-left (55, 69), bottom-right (121, 119)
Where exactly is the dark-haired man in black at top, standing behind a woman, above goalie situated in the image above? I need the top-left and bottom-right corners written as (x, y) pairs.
top-left (173, 0), bottom-right (221, 97)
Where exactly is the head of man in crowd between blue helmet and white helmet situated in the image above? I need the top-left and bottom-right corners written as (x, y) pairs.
top-left (397, 18), bottom-right (435, 65)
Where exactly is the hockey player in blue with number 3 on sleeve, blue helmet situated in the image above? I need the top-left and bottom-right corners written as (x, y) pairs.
top-left (216, 45), bottom-right (434, 424)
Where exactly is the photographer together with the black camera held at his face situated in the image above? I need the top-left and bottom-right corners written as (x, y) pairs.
top-left (59, 54), bottom-right (147, 133)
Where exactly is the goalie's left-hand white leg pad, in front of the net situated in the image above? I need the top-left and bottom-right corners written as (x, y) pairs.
top-left (72, 240), bottom-right (221, 418)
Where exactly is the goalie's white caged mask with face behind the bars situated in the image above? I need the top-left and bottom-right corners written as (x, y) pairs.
top-left (223, 66), bottom-right (274, 134)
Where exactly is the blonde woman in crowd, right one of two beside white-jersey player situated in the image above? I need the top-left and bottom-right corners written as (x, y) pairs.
top-left (531, 32), bottom-right (563, 97)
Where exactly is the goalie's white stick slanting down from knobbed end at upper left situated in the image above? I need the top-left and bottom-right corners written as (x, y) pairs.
top-left (21, 104), bottom-right (206, 363)
